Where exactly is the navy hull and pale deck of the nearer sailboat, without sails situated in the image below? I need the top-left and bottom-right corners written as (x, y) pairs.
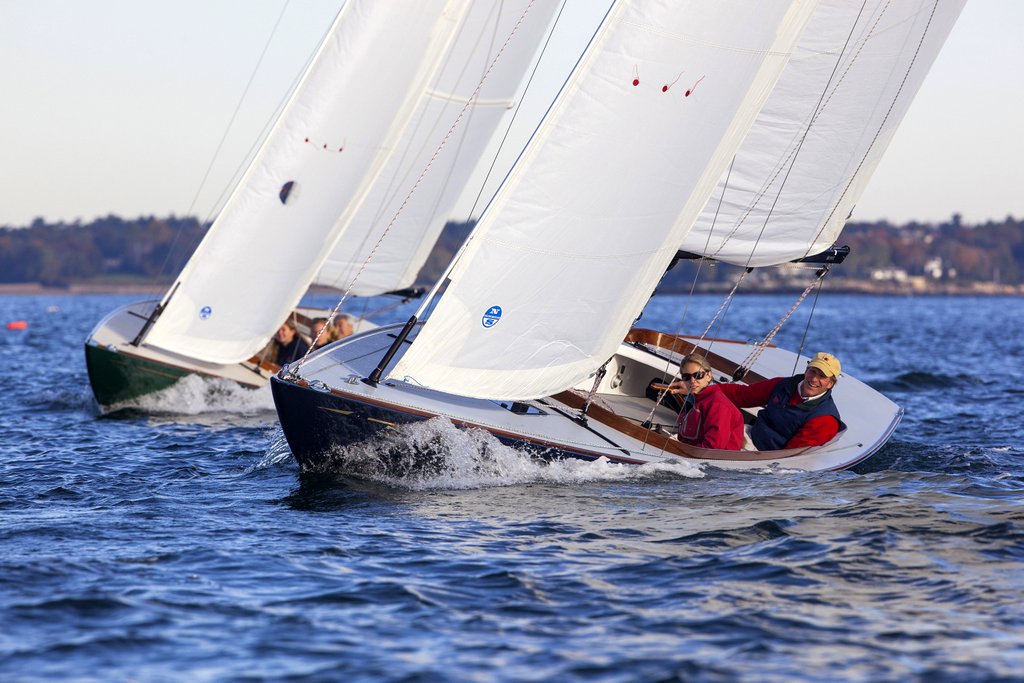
top-left (270, 328), bottom-right (902, 470)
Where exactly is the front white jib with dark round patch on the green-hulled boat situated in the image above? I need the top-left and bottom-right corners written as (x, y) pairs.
top-left (145, 0), bottom-right (554, 364)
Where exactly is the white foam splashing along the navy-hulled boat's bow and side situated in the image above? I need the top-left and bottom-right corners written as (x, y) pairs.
top-left (307, 418), bottom-right (703, 490)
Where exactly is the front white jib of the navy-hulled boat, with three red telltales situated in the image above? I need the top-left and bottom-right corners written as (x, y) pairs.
top-left (390, 0), bottom-right (814, 399)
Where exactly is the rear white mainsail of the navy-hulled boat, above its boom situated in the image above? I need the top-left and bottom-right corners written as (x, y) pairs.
top-left (682, 0), bottom-right (965, 266)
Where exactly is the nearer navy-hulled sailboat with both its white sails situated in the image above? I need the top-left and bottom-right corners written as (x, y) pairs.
top-left (271, 0), bottom-right (964, 470)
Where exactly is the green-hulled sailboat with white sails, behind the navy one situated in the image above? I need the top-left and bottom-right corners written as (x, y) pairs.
top-left (85, 0), bottom-right (569, 409)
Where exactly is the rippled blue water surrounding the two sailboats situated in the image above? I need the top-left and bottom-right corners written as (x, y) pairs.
top-left (0, 296), bottom-right (1024, 681)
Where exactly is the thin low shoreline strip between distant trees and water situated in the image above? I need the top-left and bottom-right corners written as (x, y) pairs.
top-left (0, 279), bottom-right (1024, 296)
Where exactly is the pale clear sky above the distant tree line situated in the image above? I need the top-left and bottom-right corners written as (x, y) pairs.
top-left (0, 0), bottom-right (1024, 231)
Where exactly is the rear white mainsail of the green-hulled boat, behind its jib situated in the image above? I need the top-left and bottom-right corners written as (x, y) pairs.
top-left (313, 0), bottom-right (560, 296)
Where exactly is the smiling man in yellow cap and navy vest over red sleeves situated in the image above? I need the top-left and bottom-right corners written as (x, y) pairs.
top-left (722, 353), bottom-right (845, 451)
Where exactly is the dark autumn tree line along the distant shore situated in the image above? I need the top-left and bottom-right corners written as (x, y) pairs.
top-left (0, 215), bottom-right (1024, 291)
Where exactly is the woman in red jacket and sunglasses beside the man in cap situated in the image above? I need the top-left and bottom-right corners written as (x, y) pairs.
top-left (669, 355), bottom-right (743, 451)
